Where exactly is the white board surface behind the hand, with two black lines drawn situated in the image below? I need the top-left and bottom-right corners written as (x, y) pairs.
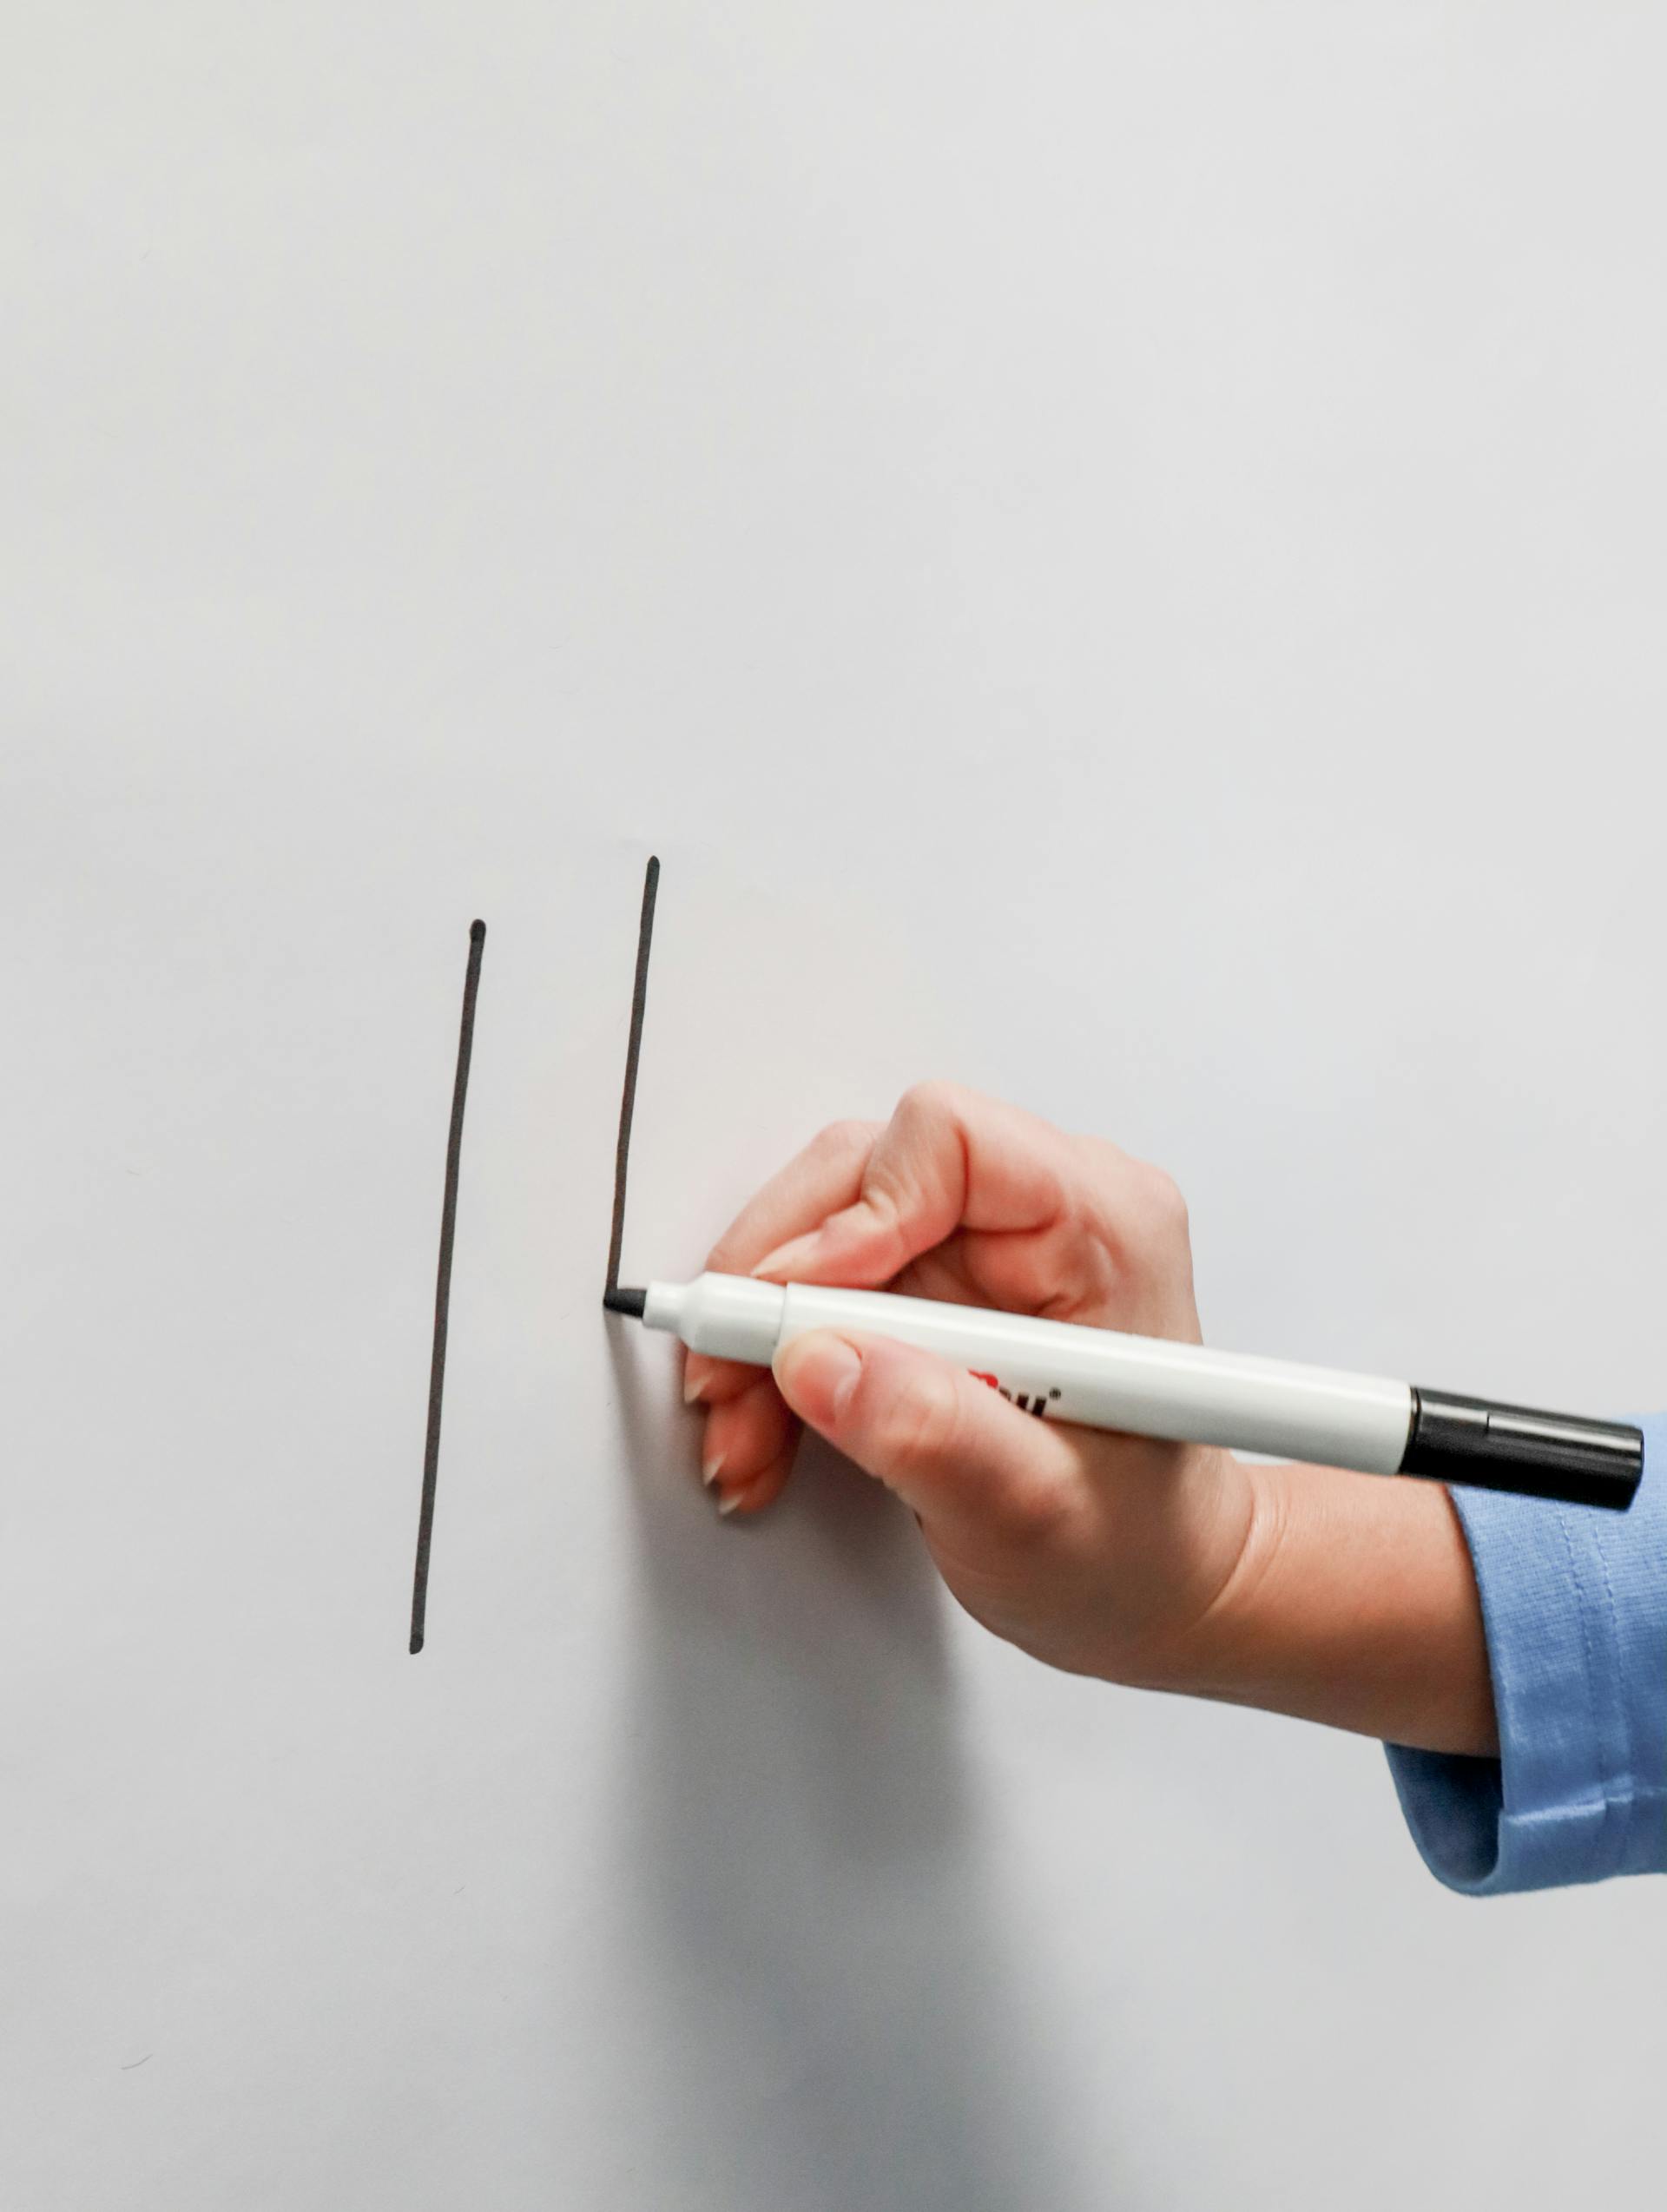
top-left (0, 0), bottom-right (1667, 2212)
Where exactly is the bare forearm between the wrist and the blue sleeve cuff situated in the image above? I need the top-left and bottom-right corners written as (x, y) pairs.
top-left (1168, 1465), bottom-right (1499, 1756)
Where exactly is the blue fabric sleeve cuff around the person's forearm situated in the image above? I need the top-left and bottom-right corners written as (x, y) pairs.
top-left (1387, 1413), bottom-right (1667, 1898)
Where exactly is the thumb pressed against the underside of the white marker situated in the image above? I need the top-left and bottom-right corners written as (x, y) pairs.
top-left (774, 1329), bottom-right (1079, 1542)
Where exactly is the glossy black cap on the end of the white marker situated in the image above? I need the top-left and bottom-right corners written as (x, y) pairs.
top-left (1400, 1385), bottom-right (1645, 1513)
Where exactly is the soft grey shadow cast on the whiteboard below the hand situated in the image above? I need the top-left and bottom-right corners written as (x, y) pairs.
top-left (610, 1336), bottom-right (1070, 2212)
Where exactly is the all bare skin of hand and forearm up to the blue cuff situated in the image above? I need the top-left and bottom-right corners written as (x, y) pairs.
top-left (685, 1084), bottom-right (1499, 1754)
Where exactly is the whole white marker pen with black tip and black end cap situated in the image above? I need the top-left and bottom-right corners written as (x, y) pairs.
top-left (603, 1274), bottom-right (1645, 1511)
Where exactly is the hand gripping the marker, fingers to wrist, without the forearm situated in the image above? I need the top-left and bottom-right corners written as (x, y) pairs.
top-left (685, 1084), bottom-right (1254, 1681)
